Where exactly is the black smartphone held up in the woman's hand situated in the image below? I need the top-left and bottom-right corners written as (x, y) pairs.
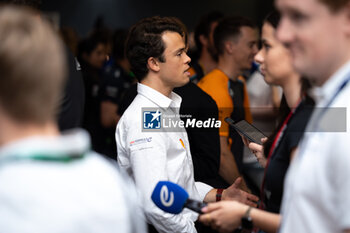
top-left (225, 117), bottom-right (266, 145)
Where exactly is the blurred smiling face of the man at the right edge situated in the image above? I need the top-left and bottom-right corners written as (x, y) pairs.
top-left (276, 0), bottom-right (349, 85)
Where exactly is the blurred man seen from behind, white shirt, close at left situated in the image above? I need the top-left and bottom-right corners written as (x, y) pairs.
top-left (0, 6), bottom-right (146, 233)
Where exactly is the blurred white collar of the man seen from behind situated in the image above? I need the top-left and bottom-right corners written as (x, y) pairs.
top-left (0, 129), bottom-right (90, 161)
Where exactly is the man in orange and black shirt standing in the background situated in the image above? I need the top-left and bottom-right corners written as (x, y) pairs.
top-left (198, 17), bottom-right (258, 191)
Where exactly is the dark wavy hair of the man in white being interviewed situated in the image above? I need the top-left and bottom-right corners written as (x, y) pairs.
top-left (126, 16), bottom-right (187, 81)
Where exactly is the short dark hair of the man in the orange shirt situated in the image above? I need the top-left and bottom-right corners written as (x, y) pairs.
top-left (214, 16), bottom-right (256, 55)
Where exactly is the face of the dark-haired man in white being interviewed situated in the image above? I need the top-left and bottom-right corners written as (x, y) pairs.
top-left (159, 32), bottom-right (191, 88)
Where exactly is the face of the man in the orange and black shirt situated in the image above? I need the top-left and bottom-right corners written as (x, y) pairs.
top-left (234, 26), bottom-right (258, 71)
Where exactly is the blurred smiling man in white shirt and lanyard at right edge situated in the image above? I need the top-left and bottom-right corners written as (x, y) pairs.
top-left (276, 0), bottom-right (350, 232)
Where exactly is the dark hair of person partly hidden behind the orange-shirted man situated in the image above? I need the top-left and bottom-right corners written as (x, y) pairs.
top-left (194, 11), bottom-right (224, 53)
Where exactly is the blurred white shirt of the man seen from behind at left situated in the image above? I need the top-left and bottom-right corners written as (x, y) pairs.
top-left (0, 130), bottom-right (146, 233)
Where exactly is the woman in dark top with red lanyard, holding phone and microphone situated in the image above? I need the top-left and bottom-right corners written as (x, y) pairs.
top-left (201, 12), bottom-right (314, 232)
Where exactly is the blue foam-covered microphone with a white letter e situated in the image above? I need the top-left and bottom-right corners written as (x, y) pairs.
top-left (151, 181), bottom-right (207, 214)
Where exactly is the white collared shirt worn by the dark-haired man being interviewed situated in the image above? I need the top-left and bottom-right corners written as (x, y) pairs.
top-left (116, 83), bottom-right (212, 233)
